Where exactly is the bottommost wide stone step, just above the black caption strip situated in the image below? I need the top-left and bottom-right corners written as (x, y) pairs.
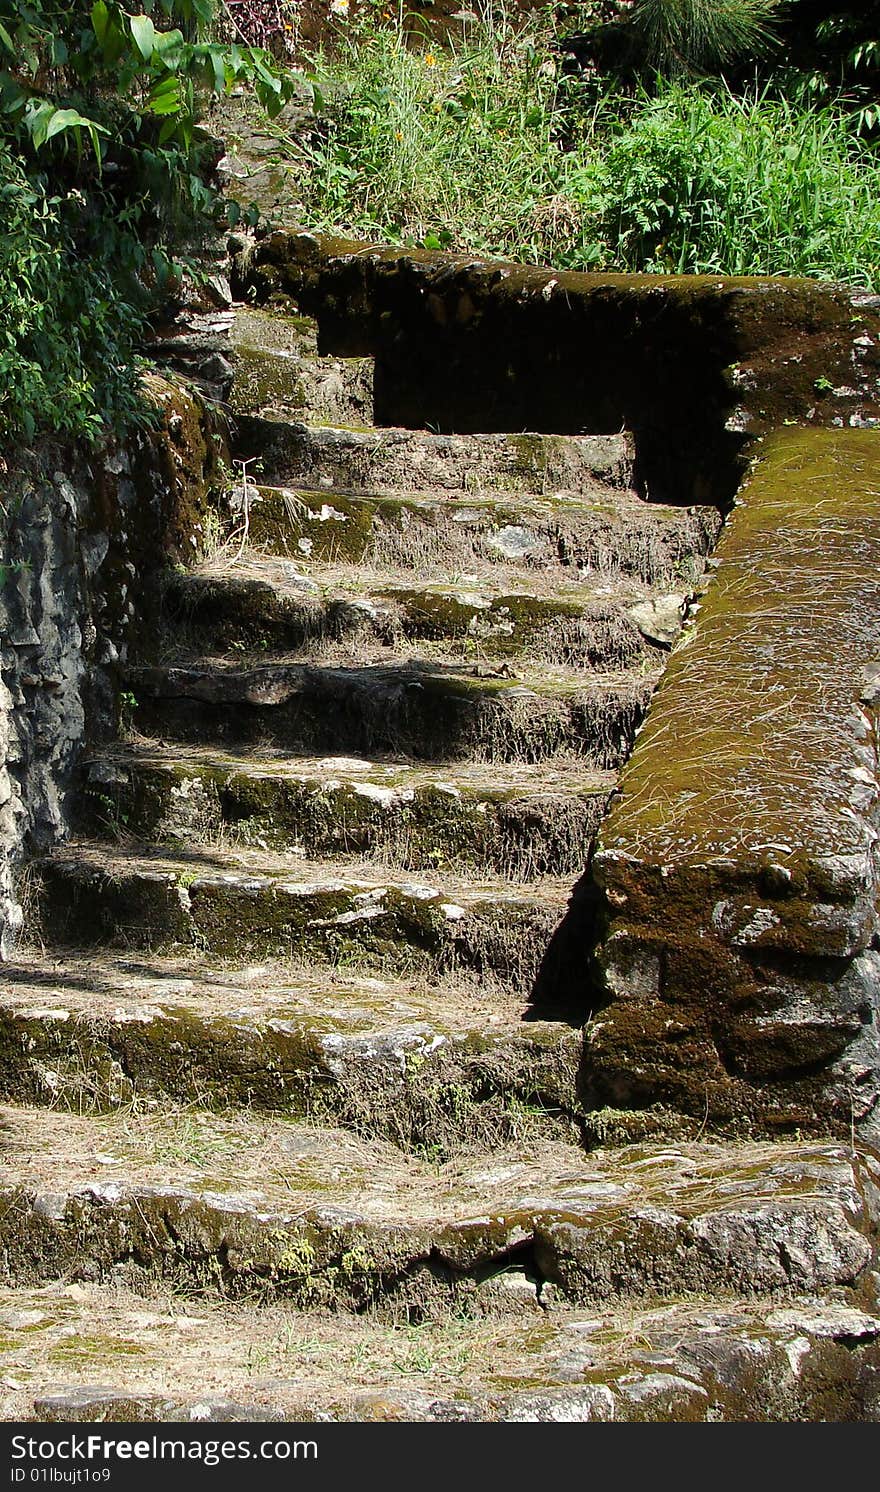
top-left (0, 1271), bottom-right (880, 1420)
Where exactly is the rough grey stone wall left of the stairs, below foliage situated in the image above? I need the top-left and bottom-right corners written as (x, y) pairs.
top-left (0, 379), bottom-right (216, 953)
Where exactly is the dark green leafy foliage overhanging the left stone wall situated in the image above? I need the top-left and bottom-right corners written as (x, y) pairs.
top-left (0, 0), bottom-right (294, 440)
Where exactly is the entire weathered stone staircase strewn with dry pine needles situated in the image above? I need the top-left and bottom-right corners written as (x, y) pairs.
top-left (0, 290), bottom-right (880, 1422)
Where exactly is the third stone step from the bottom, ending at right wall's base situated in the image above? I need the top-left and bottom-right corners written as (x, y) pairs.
top-left (0, 950), bottom-right (582, 1159)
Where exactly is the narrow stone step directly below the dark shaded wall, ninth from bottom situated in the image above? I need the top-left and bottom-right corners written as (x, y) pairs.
top-left (236, 415), bottom-right (634, 497)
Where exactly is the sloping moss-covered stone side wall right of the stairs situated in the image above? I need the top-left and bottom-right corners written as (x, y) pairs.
top-left (588, 430), bottom-right (880, 1135)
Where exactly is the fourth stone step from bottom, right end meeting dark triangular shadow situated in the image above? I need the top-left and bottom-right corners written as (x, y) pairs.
top-left (33, 843), bottom-right (586, 1009)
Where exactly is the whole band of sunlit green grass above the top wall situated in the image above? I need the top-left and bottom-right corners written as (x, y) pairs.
top-left (286, 22), bottom-right (880, 286)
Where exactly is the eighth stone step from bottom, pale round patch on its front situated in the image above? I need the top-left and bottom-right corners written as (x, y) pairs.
top-left (233, 473), bottom-right (720, 591)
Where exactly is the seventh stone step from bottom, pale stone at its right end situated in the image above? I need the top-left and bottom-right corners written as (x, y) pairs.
top-left (164, 558), bottom-right (686, 670)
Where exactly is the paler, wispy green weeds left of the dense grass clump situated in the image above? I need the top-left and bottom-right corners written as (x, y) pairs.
top-left (296, 16), bottom-right (608, 261)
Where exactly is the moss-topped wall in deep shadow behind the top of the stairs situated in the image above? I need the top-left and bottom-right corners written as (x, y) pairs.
top-left (239, 233), bottom-right (880, 506)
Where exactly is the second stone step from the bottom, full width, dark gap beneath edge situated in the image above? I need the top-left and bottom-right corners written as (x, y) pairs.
top-left (0, 1109), bottom-right (877, 1320)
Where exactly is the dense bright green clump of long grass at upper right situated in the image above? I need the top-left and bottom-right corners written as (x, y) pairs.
top-left (601, 85), bottom-right (880, 285)
